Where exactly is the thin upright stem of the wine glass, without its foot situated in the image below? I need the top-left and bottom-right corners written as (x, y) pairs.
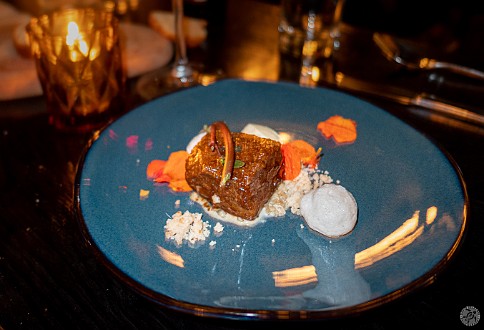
top-left (172, 0), bottom-right (193, 79)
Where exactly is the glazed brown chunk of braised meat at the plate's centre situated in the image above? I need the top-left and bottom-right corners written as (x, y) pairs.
top-left (185, 132), bottom-right (282, 220)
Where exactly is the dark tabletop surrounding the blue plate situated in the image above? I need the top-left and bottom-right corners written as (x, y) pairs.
top-left (0, 0), bottom-right (484, 329)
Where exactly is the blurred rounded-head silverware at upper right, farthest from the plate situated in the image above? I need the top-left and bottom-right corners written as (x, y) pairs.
top-left (373, 32), bottom-right (484, 79)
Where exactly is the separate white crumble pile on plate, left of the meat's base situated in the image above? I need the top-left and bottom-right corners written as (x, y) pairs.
top-left (164, 211), bottom-right (210, 246)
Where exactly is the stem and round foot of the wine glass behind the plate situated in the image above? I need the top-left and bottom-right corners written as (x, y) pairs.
top-left (136, 0), bottom-right (200, 101)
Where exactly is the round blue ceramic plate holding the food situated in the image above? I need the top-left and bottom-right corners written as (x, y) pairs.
top-left (77, 80), bottom-right (467, 318)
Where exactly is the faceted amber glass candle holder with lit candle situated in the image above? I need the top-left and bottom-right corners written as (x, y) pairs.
top-left (27, 8), bottom-right (125, 131)
